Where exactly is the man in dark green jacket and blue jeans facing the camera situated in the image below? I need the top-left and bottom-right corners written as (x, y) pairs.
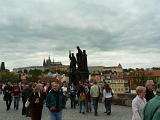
top-left (46, 80), bottom-right (65, 120)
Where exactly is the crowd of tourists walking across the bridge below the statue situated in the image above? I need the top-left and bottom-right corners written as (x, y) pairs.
top-left (2, 80), bottom-right (114, 120)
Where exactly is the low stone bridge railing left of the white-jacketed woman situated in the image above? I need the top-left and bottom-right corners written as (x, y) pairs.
top-left (113, 93), bottom-right (136, 106)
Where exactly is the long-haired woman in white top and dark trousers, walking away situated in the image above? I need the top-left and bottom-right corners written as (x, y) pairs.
top-left (103, 84), bottom-right (113, 115)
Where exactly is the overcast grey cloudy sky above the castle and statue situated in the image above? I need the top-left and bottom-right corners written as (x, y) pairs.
top-left (0, 0), bottom-right (160, 69)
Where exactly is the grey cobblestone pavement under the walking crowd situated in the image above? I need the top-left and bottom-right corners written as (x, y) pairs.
top-left (0, 95), bottom-right (132, 120)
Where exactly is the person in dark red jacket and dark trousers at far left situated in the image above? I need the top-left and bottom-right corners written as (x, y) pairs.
top-left (12, 83), bottom-right (20, 110)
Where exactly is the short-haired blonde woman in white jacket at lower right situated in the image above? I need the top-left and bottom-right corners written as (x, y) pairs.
top-left (132, 86), bottom-right (146, 120)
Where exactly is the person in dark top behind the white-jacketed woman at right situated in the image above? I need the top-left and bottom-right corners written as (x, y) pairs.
top-left (145, 80), bottom-right (155, 102)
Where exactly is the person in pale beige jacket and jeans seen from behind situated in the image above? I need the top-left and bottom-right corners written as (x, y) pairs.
top-left (90, 81), bottom-right (101, 116)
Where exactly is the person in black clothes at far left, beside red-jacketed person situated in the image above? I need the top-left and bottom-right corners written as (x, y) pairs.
top-left (3, 82), bottom-right (12, 111)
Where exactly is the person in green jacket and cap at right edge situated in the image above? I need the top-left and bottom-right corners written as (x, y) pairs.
top-left (143, 81), bottom-right (160, 120)
